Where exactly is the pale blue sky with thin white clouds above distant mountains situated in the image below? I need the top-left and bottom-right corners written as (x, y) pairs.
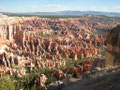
top-left (0, 0), bottom-right (120, 13)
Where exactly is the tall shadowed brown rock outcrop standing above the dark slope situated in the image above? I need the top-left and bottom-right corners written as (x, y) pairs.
top-left (106, 26), bottom-right (120, 66)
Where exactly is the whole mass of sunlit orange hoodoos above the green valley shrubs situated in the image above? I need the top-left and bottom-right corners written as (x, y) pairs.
top-left (0, 13), bottom-right (116, 75)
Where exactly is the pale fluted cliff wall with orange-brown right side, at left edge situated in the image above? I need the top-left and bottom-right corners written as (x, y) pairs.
top-left (0, 24), bottom-right (25, 45)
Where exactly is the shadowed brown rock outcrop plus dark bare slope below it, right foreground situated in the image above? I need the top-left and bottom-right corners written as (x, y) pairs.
top-left (62, 26), bottom-right (120, 90)
